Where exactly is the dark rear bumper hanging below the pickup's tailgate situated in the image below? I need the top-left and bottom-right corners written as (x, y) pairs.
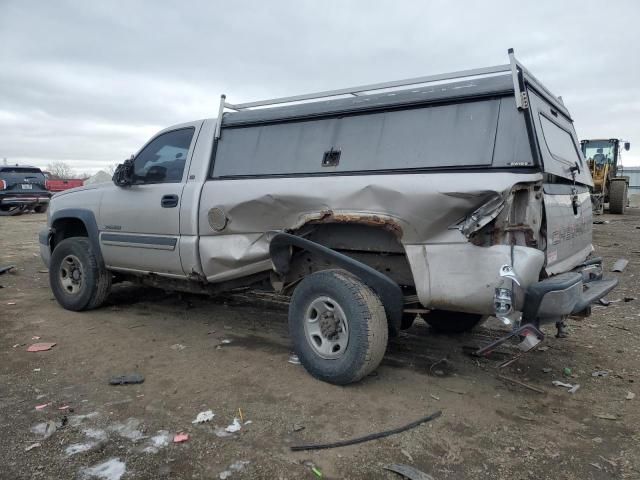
top-left (522, 259), bottom-right (618, 324)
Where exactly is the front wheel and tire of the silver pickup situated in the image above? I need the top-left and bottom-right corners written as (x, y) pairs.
top-left (49, 237), bottom-right (111, 312)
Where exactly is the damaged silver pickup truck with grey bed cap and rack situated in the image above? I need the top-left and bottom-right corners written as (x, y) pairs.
top-left (40, 50), bottom-right (616, 384)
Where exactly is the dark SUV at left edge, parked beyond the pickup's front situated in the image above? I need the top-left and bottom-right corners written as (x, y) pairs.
top-left (0, 165), bottom-right (51, 216)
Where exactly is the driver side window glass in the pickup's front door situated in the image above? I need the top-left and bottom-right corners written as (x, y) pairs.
top-left (132, 127), bottom-right (195, 185)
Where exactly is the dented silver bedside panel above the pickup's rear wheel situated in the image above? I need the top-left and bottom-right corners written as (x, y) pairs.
top-left (199, 171), bottom-right (541, 308)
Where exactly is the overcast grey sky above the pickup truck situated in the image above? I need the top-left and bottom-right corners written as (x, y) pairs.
top-left (0, 0), bottom-right (640, 172)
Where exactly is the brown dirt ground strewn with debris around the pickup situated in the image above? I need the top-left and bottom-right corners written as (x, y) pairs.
top-left (0, 209), bottom-right (640, 480)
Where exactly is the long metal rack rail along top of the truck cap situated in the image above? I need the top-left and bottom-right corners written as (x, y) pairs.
top-left (225, 64), bottom-right (511, 110)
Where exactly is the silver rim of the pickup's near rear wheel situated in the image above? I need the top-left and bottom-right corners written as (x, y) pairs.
top-left (304, 297), bottom-right (349, 360)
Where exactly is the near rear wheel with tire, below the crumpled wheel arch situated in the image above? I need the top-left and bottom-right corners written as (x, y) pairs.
top-left (289, 270), bottom-right (389, 385)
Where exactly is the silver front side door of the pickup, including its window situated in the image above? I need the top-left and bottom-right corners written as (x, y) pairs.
top-left (98, 122), bottom-right (202, 276)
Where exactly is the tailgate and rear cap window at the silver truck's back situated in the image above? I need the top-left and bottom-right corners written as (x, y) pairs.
top-left (528, 91), bottom-right (593, 274)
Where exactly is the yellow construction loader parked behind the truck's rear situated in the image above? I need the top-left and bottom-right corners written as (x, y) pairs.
top-left (580, 138), bottom-right (631, 214)
